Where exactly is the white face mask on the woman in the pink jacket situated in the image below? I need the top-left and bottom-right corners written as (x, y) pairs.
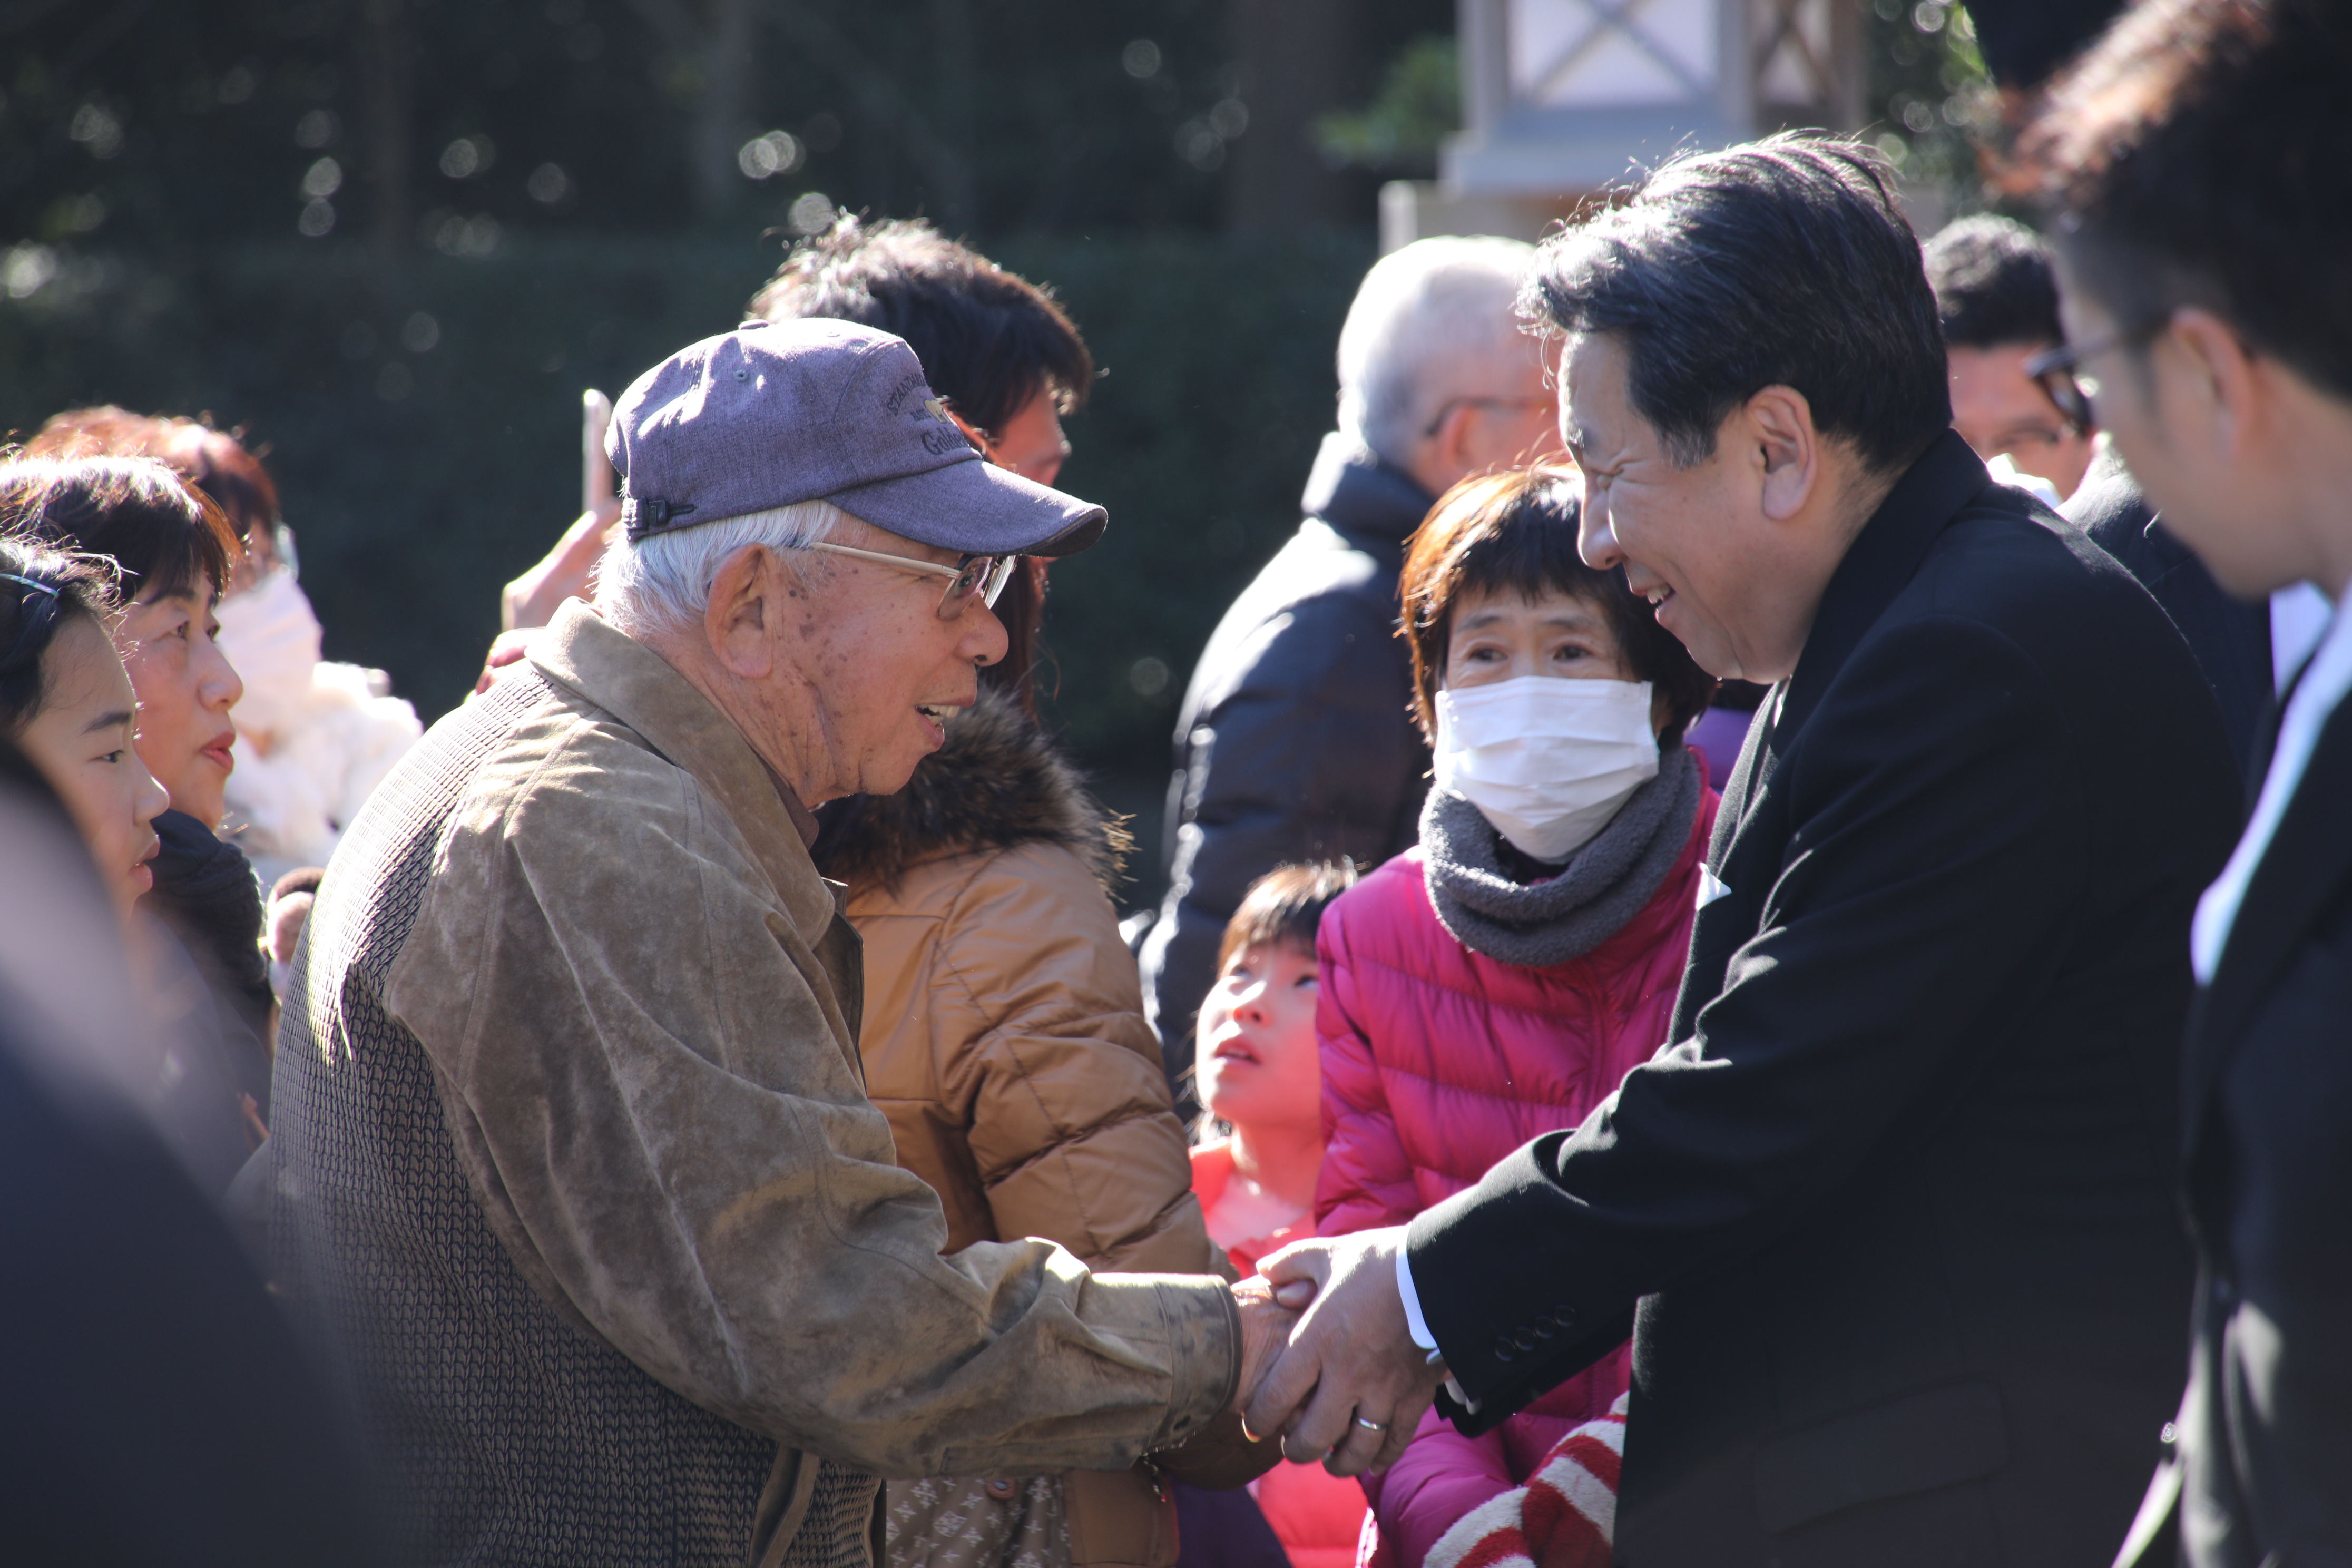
top-left (1437, 675), bottom-right (1658, 863)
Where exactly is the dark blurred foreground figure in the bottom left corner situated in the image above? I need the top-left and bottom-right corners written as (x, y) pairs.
top-left (0, 740), bottom-right (381, 1568)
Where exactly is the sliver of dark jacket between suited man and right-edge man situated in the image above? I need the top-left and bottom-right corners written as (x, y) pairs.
top-left (2065, 456), bottom-right (2272, 776)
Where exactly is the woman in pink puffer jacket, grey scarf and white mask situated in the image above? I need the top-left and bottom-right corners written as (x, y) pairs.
top-left (1315, 468), bottom-right (1714, 1568)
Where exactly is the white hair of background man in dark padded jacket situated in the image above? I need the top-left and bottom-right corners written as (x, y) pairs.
top-left (1338, 235), bottom-right (1536, 463)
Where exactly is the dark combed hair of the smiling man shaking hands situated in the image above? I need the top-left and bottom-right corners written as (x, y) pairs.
top-left (1520, 132), bottom-right (1952, 473)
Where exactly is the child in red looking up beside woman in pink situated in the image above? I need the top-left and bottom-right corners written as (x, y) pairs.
top-left (1183, 865), bottom-right (1364, 1568)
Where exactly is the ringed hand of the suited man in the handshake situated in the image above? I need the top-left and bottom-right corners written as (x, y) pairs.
top-left (1242, 1227), bottom-right (1444, 1476)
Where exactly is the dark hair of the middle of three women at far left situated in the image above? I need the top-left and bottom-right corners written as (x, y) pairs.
top-left (0, 458), bottom-right (244, 600)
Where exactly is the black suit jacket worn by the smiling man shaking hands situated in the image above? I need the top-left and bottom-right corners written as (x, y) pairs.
top-left (1409, 435), bottom-right (2241, 1568)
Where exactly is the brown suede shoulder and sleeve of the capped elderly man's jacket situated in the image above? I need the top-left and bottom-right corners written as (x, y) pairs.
top-left (327, 604), bottom-right (1240, 1561)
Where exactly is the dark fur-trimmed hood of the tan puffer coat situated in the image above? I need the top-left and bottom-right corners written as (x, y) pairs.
top-left (814, 691), bottom-right (1134, 891)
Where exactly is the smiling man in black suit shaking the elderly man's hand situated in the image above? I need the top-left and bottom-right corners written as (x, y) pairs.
top-left (1249, 136), bottom-right (2241, 1568)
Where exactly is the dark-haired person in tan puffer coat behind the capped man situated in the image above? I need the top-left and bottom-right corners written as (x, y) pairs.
top-left (750, 216), bottom-right (1218, 1568)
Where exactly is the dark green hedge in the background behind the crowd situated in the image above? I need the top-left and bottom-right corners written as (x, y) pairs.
top-left (0, 235), bottom-right (1374, 884)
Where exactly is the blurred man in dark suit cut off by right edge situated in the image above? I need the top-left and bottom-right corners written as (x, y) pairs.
top-left (2025, 0), bottom-right (2352, 1568)
